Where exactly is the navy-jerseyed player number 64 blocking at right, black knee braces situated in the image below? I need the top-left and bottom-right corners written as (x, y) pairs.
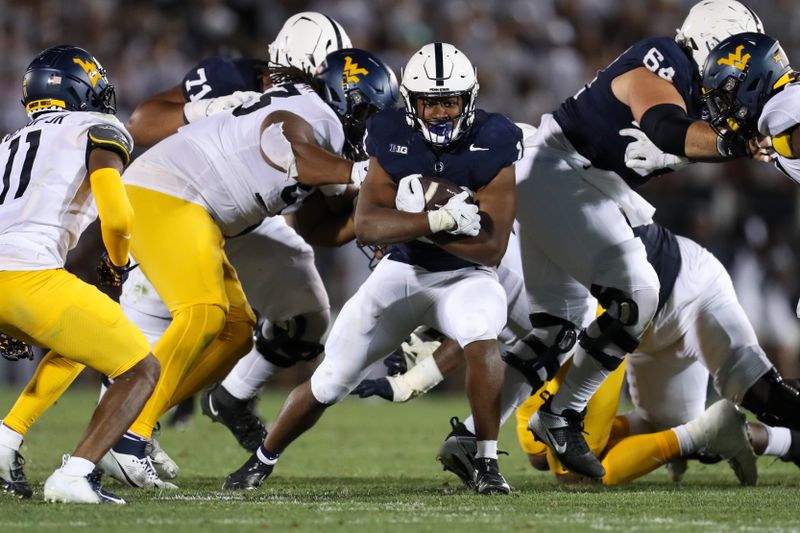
top-left (510, 0), bottom-right (762, 478)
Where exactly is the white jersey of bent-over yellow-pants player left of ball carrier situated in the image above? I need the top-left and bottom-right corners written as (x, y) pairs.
top-left (123, 84), bottom-right (344, 237)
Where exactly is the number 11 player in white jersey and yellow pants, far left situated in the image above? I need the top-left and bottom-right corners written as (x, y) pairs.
top-left (0, 45), bottom-right (159, 503)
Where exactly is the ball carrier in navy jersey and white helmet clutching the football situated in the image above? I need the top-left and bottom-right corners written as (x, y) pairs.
top-left (224, 42), bottom-right (522, 494)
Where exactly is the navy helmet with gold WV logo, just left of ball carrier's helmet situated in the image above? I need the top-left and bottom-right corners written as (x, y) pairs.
top-left (312, 48), bottom-right (400, 161)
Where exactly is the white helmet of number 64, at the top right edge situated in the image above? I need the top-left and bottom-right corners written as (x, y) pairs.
top-left (675, 0), bottom-right (764, 76)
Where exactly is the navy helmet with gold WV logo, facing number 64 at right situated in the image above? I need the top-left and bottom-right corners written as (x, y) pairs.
top-left (703, 33), bottom-right (797, 139)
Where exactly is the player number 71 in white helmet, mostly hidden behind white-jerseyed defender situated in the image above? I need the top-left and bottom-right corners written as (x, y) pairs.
top-left (120, 12), bottom-right (354, 454)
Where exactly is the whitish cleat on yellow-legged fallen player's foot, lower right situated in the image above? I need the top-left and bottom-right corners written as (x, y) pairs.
top-left (686, 400), bottom-right (758, 486)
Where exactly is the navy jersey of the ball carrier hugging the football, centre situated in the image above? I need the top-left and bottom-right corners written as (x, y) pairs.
top-left (366, 109), bottom-right (522, 271)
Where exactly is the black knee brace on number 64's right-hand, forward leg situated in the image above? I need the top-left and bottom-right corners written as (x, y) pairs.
top-left (578, 285), bottom-right (658, 371)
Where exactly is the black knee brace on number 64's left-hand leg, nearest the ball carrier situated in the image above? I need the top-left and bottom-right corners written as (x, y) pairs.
top-left (502, 313), bottom-right (578, 390)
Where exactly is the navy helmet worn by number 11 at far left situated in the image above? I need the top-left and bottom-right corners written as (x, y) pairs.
top-left (22, 45), bottom-right (117, 116)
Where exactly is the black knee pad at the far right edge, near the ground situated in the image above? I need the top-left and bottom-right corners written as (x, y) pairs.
top-left (742, 368), bottom-right (800, 431)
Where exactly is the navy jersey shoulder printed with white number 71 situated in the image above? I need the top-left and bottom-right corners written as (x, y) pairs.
top-left (181, 56), bottom-right (267, 102)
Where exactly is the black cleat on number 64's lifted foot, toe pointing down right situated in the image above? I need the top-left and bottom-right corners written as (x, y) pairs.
top-left (528, 397), bottom-right (606, 479)
